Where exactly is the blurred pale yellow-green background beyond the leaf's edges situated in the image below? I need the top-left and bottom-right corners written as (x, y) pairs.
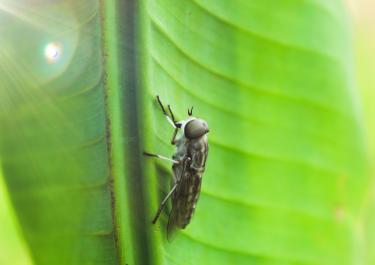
top-left (0, 0), bottom-right (375, 265)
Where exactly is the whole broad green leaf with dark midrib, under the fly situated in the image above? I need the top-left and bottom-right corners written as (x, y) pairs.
top-left (0, 0), bottom-right (369, 265)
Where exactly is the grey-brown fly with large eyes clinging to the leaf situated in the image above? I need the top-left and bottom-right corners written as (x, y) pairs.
top-left (144, 96), bottom-right (209, 238)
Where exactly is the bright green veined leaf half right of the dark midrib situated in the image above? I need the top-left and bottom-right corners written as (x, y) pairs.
top-left (148, 0), bottom-right (369, 265)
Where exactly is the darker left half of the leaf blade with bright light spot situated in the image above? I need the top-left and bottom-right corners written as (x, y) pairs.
top-left (0, 1), bottom-right (118, 265)
